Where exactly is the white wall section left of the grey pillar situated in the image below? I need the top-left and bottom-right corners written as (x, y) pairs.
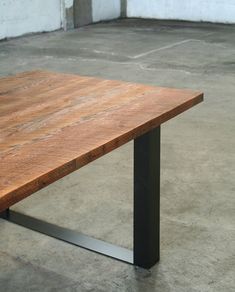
top-left (0, 0), bottom-right (61, 39)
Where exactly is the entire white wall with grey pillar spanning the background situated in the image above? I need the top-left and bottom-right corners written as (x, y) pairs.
top-left (0, 0), bottom-right (235, 39)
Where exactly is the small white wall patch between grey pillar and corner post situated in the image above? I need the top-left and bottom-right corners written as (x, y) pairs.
top-left (92, 0), bottom-right (121, 22)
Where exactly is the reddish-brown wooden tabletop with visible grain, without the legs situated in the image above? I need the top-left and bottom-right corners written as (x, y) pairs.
top-left (0, 71), bottom-right (203, 211)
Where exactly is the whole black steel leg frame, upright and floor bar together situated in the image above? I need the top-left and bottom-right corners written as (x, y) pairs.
top-left (0, 127), bottom-right (160, 269)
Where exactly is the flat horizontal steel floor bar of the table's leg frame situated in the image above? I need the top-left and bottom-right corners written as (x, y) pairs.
top-left (0, 210), bottom-right (134, 264)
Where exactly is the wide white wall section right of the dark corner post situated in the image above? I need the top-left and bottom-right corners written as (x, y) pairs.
top-left (127, 0), bottom-right (235, 23)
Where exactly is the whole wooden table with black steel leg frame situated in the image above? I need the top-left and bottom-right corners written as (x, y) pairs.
top-left (0, 71), bottom-right (203, 268)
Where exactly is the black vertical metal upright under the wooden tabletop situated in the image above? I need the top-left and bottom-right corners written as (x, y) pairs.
top-left (134, 127), bottom-right (160, 269)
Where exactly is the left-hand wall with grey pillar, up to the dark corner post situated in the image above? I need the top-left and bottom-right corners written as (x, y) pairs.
top-left (0, 0), bottom-right (121, 39)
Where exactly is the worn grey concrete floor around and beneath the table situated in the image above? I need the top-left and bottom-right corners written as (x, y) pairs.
top-left (0, 20), bottom-right (235, 292)
